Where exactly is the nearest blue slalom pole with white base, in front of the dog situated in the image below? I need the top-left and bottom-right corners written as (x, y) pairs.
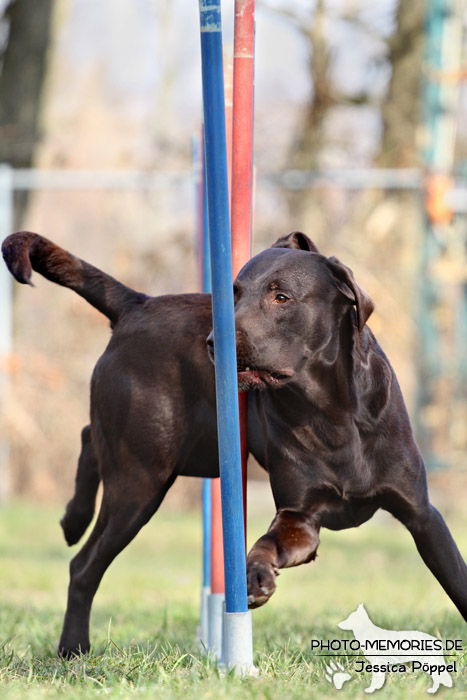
top-left (200, 0), bottom-right (252, 670)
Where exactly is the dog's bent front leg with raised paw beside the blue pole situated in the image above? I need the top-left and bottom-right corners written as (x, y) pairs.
top-left (247, 508), bottom-right (320, 608)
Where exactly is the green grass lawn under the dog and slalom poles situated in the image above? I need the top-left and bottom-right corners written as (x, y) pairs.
top-left (0, 494), bottom-right (467, 700)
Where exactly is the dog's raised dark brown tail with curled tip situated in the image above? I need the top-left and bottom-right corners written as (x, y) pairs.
top-left (2, 231), bottom-right (147, 324)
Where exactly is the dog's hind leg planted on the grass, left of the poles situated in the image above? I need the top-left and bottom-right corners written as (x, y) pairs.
top-left (58, 465), bottom-right (175, 658)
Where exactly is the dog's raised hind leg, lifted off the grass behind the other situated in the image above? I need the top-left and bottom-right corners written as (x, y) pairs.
top-left (60, 425), bottom-right (101, 546)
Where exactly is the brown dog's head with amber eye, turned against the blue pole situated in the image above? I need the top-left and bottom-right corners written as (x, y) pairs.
top-left (208, 232), bottom-right (374, 391)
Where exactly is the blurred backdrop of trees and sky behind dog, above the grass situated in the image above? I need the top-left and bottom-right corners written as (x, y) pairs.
top-left (0, 0), bottom-right (467, 504)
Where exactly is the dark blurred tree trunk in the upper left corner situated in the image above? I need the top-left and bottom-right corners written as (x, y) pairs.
top-left (0, 0), bottom-right (54, 225)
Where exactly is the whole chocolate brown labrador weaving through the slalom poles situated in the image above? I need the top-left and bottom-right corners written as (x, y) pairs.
top-left (3, 232), bottom-right (467, 656)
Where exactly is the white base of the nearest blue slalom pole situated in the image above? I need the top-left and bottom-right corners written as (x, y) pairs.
top-left (222, 610), bottom-right (258, 676)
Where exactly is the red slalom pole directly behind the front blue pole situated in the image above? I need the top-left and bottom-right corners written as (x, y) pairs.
top-left (230, 0), bottom-right (255, 538)
